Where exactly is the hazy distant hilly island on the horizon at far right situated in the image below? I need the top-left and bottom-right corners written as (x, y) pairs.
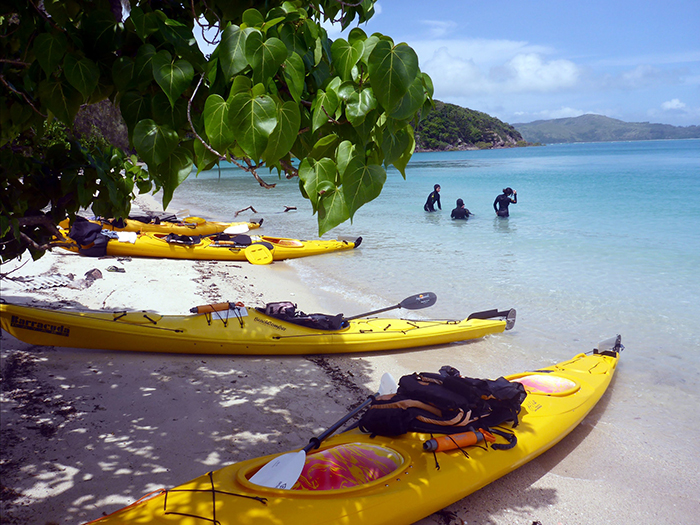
top-left (513, 114), bottom-right (700, 144)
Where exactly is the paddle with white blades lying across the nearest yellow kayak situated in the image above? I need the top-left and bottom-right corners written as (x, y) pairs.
top-left (250, 372), bottom-right (397, 489)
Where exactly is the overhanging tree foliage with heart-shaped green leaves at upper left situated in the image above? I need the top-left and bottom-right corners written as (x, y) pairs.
top-left (0, 0), bottom-right (432, 260)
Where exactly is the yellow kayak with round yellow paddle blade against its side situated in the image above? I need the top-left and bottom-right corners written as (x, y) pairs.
top-left (57, 230), bottom-right (362, 264)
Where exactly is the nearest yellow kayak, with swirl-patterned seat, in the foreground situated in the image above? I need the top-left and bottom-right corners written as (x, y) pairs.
top-left (83, 336), bottom-right (622, 525)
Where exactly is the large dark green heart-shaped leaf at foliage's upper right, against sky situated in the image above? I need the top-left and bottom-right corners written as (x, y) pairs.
top-left (368, 40), bottom-right (419, 111)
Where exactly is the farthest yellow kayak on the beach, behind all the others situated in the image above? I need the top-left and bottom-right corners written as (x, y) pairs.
top-left (59, 217), bottom-right (263, 235)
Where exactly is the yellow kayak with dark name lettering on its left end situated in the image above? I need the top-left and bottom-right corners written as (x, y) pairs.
top-left (0, 294), bottom-right (515, 355)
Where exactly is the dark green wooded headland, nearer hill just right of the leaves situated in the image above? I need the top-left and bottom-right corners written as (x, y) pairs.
top-left (416, 100), bottom-right (527, 151)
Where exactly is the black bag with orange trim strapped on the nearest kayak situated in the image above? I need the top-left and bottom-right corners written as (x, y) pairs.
top-left (358, 367), bottom-right (526, 436)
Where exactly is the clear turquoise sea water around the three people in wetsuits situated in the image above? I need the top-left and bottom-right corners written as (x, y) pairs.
top-left (170, 140), bottom-right (700, 390)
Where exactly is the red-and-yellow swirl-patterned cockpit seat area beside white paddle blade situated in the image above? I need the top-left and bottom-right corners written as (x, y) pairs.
top-left (292, 443), bottom-right (403, 490)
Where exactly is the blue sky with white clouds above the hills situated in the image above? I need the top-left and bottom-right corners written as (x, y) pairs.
top-left (326, 0), bottom-right (700, 126)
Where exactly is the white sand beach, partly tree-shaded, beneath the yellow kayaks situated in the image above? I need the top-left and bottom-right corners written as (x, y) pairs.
top-left (0, 195), bottom-right (696, 525)
